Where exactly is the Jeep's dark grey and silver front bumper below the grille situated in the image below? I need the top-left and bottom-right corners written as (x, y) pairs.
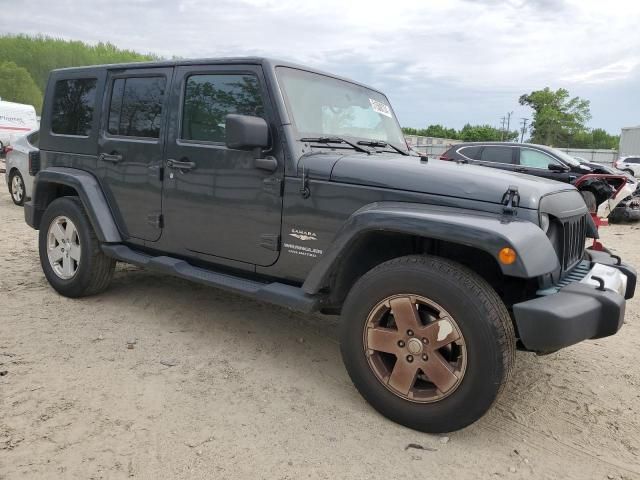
top-left (513, 251), bottom-right (637, 353)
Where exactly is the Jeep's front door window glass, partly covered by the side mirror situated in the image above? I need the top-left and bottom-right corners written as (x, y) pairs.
top-left (181, 74), bottom-right (264, 143)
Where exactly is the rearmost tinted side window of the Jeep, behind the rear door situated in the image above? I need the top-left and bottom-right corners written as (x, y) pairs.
top-left (51, 78), bottom-right (97, 137)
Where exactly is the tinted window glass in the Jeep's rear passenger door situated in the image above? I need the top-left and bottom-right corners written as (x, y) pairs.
top-left (108, 77), bottom-right (166, 138)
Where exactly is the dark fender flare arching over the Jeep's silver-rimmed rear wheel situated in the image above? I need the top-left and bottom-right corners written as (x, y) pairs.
top-left (24, 167), bottom-right (122, 243)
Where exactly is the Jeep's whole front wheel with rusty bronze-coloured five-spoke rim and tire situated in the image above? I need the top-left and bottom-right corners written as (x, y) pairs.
top-left (341, 255), bottom-right (515, 433)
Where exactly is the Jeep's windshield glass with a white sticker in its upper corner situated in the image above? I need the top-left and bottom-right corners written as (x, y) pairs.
top-left (277, 67), bottom-right (407, 150)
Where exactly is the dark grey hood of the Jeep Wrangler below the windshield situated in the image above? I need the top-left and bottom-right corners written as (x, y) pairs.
top-left (304, 153), bottom-right (575, 209)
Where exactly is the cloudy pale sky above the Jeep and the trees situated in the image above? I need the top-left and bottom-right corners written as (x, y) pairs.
top-left (0, 0), bottom-right (640, 134)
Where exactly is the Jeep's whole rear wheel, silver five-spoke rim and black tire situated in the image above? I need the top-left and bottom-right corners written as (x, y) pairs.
top-left (38, 197), bottom-right (115, 297)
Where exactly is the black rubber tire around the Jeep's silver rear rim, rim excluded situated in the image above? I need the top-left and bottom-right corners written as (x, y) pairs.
top-left (38, 197), bottom-right (116, 298)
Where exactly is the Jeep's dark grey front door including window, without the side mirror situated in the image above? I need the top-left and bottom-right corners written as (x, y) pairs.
top-left (163, 65), bottom-right (284, 266)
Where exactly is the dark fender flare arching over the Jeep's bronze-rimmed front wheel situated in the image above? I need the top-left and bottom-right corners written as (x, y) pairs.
top-left (302, 202), bottom-right (560, 294)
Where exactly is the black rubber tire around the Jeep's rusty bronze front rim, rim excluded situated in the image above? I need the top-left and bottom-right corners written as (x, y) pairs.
top-left (340, 255), bottom-right (516, 433)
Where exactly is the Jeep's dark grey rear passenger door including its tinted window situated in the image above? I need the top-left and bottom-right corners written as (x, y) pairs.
top-left (96, 68), bottom-right (173, 241)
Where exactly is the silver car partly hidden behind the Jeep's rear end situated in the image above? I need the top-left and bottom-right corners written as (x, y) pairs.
top-left (5, 130), bottom-right (40, 205)
